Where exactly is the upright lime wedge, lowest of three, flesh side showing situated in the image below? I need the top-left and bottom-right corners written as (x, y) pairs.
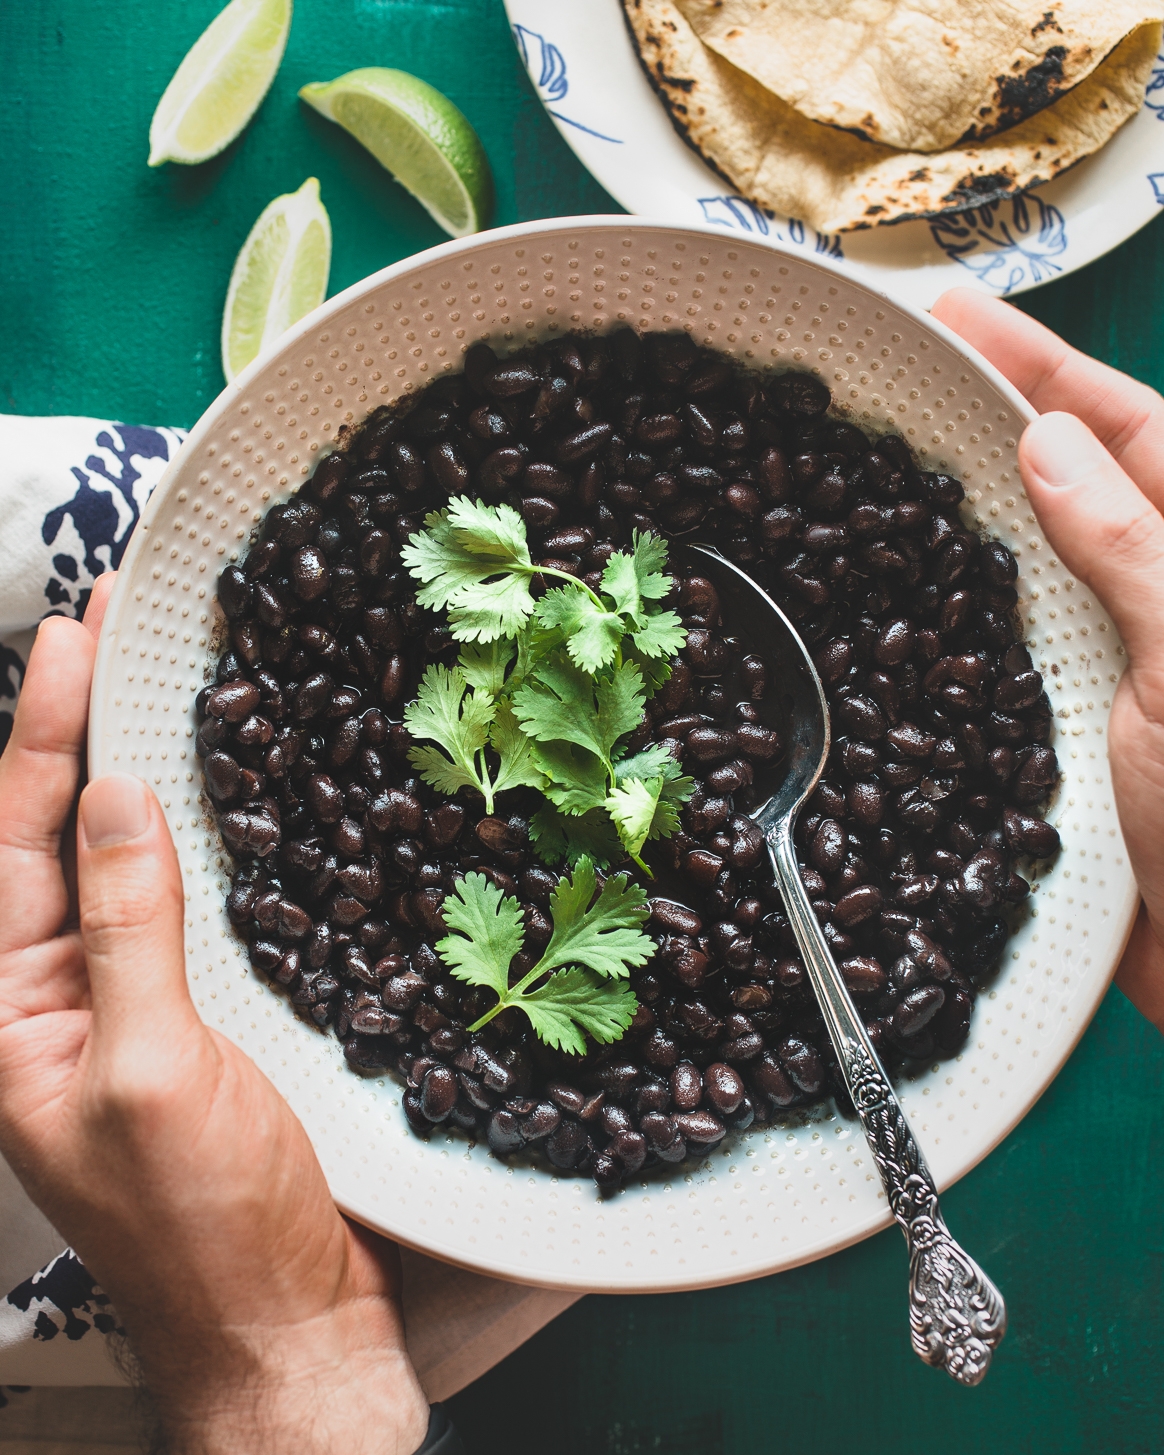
top-left (223, 178), bottom-right (332, 381)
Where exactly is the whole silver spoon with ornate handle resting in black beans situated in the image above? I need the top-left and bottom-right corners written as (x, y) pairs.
top-left (685, 544), bottom-right (1007, 1385)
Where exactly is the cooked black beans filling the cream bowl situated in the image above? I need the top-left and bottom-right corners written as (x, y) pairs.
top-left (198, 330), bottom-right (1058, 1190)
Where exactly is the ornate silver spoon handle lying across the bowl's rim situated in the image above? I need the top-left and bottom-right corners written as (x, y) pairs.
top-left (767, 821), bottom-right (1007, 1384)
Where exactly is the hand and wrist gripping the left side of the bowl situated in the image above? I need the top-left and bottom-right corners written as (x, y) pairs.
top-left (0, 576), bottom-right (428, 1455)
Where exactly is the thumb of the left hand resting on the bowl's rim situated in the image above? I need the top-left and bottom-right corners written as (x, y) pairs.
top-left (77, 773), bottom-right (196, 1052)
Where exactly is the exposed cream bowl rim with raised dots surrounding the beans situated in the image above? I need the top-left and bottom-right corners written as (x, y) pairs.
top-left (89, 217), bottom-right (1136, 1292)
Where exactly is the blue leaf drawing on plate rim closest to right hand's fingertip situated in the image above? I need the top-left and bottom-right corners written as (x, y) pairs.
top-left (930, 192), bottom-right (1067, 294)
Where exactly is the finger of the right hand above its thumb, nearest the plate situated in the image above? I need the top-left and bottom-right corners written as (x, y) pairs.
top-left (933, 288), bottom-right (1164, 508)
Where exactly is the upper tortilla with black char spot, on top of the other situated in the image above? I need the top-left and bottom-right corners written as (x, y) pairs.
top-left (678, 0), bottom-right (1164, 151)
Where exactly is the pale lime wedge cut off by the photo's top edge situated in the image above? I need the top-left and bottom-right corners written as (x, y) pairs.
top-left (150, 0), bottom-right (291, 167)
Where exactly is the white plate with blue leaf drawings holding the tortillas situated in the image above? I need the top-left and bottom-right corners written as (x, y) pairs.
top-left (505, 0), bottom-right (1164, 308)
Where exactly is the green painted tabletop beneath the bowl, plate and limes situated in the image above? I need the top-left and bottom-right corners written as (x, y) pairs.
top-left (0, 0), bottom-right (1164, 1455)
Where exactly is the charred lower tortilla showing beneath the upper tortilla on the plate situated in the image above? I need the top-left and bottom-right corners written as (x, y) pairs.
top-left (623, 0), bottom-right (1161, 233)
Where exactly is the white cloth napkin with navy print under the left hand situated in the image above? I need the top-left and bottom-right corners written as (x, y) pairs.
top-left (0, 415), bottom-right (578, 1400)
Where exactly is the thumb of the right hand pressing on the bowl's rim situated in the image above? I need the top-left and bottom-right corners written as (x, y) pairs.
top-left (1019, 413), bottom-right (1164, 666)
